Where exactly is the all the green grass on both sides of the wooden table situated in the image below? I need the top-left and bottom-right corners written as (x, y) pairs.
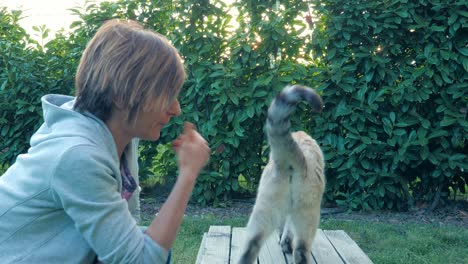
top-left (144, 215), bottom-right (468, 264)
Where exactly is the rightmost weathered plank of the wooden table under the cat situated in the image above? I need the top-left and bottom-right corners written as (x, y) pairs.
top-left (324, 230), bottom-right (372, 264)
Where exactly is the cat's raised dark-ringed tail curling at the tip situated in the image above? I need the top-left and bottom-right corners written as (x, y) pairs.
top-left (266, 85), bottom-right (323, 159)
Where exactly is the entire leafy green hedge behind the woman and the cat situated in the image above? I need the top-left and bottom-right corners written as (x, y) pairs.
top-left (0, 0), bottom-right (468, 210)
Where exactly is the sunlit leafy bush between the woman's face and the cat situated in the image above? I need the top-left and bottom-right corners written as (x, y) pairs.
top-left (65, 1), bottom-right (315, 205)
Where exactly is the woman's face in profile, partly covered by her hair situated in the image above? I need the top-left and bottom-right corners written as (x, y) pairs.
top-left (133, 99), bottom-right (181, 140)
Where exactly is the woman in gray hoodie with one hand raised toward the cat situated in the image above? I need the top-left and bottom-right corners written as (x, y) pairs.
top-left (0, 20), bottom-right (210, 263)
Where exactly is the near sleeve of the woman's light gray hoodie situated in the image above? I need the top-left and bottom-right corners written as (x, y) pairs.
top-left (51, 145), bottom-right (168, 263)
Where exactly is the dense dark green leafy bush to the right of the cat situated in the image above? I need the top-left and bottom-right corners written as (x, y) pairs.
top-left (313, 0), bottom-right (468, 209)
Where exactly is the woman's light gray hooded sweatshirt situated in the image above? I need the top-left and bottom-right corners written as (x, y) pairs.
top-left (0, 95), bottom-right (168, 263)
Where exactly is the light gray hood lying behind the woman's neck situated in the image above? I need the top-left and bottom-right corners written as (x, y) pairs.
top-left (30, 94), bottom-right (119, 164)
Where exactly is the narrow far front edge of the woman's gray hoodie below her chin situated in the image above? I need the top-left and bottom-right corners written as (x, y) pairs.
top-left (125, 138), bottom-right (141, 223)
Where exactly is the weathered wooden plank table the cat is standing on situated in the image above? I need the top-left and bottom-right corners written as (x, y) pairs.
top-left (196, 226), bottom-right (372, 264)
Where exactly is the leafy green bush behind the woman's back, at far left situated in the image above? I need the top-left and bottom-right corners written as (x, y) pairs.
top-left (0, 8), bottom-right (73, 165)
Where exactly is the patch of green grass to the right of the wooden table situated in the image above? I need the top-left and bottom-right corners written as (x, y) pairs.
top-left (321, 220), bottom-right (468, 264)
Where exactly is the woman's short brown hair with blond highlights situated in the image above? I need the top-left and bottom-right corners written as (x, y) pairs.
top-left (74, 20), bottom-right (186, 122)
